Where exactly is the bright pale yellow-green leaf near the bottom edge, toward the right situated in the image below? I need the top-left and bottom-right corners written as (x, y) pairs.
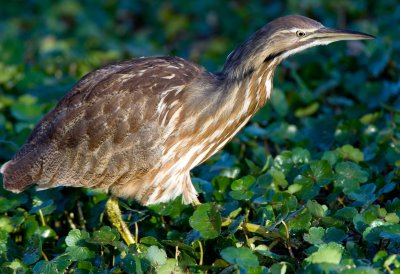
top-left (305, 243), bottom-right (344, 265)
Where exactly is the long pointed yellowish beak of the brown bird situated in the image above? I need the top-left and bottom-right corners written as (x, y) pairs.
top-left (314, 27), bottom-right (375, 43)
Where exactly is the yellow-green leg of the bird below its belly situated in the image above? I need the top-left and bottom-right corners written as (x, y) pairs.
top-left (106, 196), bottom-right (135, 246)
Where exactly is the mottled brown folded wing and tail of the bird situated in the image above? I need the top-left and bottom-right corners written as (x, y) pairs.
top-left (2, 57), bottom-right (203, 192)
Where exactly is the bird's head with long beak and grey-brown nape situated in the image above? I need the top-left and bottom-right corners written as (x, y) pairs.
top-left (224, 15), bottom-right (374, 78)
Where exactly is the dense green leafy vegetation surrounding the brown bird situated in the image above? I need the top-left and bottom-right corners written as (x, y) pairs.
top-left (0, 0), bottom-right (400, 273)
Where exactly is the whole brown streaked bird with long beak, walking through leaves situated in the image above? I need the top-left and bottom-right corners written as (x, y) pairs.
top-left (1, 15), bottom-right (374, 244)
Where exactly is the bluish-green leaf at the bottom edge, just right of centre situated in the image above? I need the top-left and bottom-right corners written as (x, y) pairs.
top-left (221, 247), bottom-right (259, 270)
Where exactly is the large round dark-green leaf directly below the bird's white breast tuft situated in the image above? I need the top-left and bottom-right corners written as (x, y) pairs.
top-left (189, 203), bottom-right (221, 239)
